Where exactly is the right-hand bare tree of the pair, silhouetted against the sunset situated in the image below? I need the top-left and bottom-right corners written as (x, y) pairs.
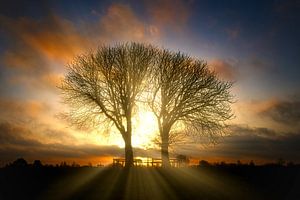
top-left (148, 50), bottom-right (233, 166)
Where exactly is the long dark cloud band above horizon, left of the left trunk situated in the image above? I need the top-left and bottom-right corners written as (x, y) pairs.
top-left (0, 123), bottom-right (115, 157)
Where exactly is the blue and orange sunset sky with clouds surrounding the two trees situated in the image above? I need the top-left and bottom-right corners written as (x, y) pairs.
top-left (0, 0), bottom-right (300, 165)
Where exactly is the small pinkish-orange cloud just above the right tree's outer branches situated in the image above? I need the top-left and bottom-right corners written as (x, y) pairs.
top-left (208, 59), bottom-right (238, 81)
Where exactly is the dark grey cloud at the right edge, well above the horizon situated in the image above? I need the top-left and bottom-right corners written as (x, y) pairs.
top-left (260, 101), bottom-right (300, 126)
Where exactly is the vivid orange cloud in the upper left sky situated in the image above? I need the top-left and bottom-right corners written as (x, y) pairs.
top-left (1, 15), bottom-right (88, 61)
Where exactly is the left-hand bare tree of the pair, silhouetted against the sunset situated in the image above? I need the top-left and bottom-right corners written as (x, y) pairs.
top-left (60, 43), bottom-right (156, 167)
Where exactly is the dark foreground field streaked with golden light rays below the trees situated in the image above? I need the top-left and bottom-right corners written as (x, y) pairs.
top-left (0, 166), bottom-right (300, 200)
